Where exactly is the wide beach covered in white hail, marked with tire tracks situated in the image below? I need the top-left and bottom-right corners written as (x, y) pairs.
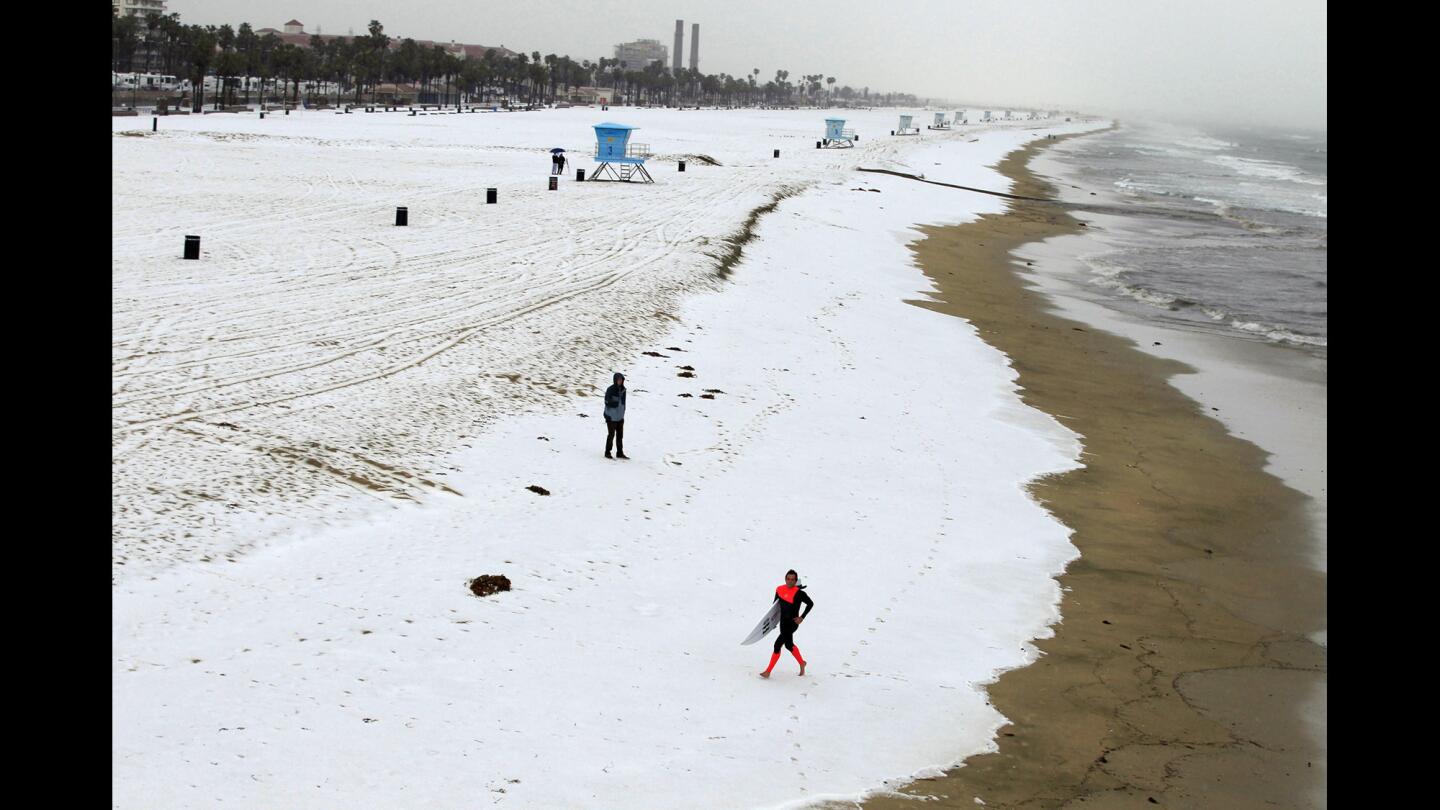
top-left (112, 108), bottom-right (1324, 809)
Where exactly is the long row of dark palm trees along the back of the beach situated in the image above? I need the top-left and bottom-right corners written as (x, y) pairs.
top-left (112, 13), bottom-right (917, 111)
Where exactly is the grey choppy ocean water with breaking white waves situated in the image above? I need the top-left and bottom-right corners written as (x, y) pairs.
top-left (1036, 123), bottom-right (1329, 355)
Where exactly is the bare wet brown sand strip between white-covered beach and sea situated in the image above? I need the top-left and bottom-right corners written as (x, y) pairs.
top-left (865, 135), bottom-right (1326, 809)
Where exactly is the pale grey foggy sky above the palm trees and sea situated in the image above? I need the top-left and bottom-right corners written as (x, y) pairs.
top-left (167, 0), bottom-right (1328, 130)
